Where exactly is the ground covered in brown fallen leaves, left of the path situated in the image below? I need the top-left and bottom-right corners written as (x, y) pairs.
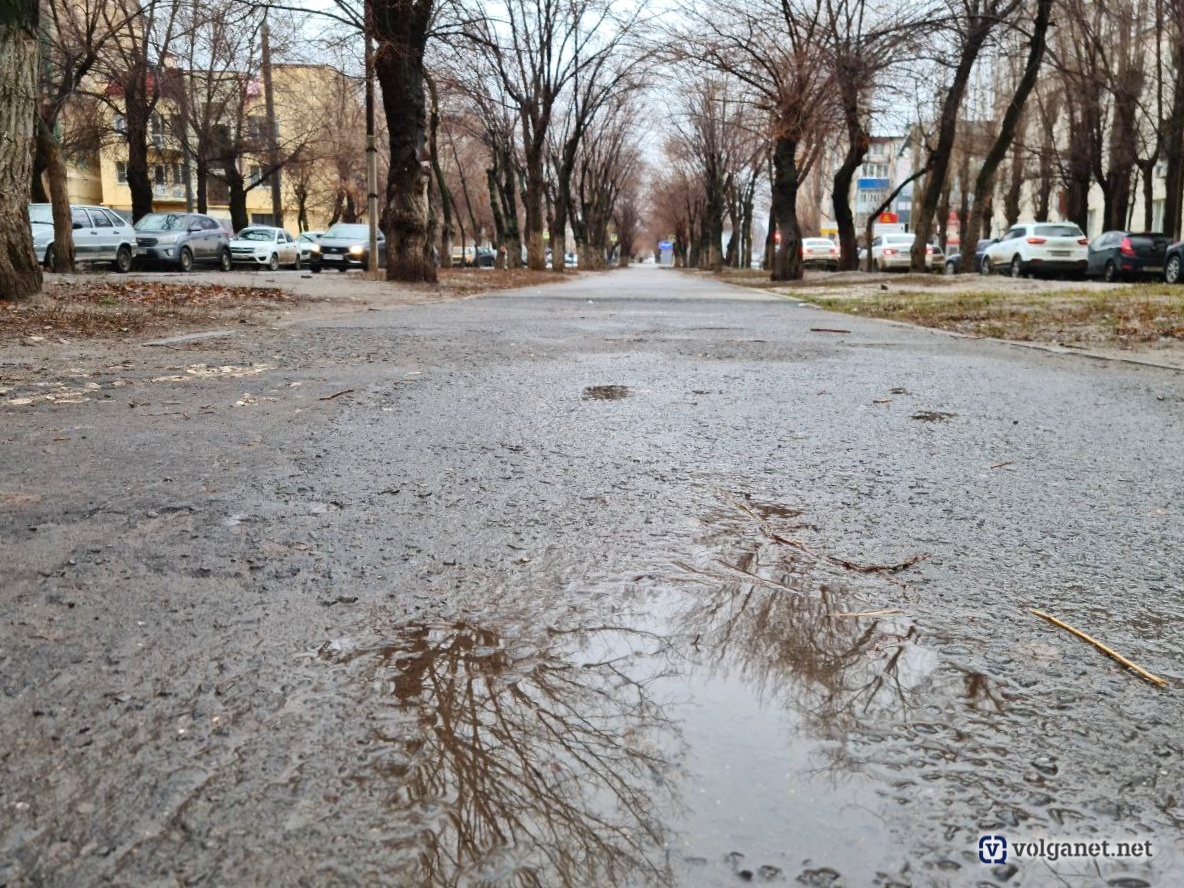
top-left (0, 279), bottom-right (294, 342)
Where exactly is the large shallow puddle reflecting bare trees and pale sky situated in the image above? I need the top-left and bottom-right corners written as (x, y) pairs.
top-left (300, 504), bottom-right (1170, 888)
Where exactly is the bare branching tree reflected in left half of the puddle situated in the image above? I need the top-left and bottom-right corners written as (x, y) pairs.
top-left (320, 624), bottom-right (678, 887)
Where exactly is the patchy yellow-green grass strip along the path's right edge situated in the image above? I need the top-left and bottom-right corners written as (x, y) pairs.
top-left (796, 284), bottom-right (1184, 348)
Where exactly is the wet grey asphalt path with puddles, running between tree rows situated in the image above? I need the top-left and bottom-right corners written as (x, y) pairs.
top-left (0, 269), bottom-right (1184, 888)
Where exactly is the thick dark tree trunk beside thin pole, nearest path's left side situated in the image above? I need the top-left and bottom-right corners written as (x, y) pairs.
top-left (371, 0), bottom-right (436, 283)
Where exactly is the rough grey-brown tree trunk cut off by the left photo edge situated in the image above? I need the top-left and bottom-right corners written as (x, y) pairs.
top-left (0, 0), bottom-right (41, 300)
